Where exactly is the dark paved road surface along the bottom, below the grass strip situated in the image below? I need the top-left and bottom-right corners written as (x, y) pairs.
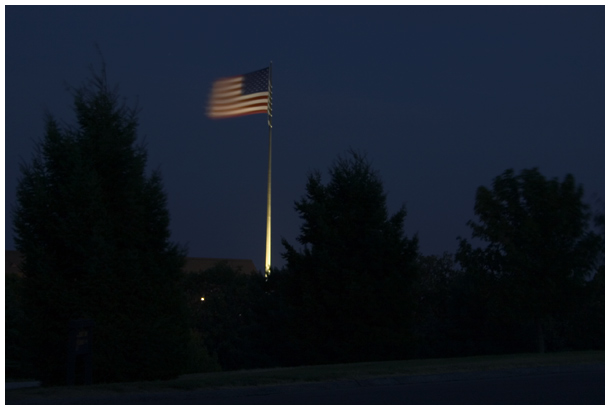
top-left (5, 364), bottom-right (605, 405)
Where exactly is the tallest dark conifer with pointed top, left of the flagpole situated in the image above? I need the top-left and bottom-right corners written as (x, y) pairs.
top-left (14, 68), bottom-right (188, 384)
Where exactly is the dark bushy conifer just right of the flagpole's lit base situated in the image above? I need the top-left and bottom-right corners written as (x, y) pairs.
top-left (282, 152), bottom-right (418, 362)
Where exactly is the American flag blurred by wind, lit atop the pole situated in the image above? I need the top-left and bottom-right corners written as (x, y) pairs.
top-left (208, 68), bottom-right (269, 118)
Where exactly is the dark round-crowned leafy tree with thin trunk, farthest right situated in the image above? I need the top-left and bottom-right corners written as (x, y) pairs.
top-left (457, 168), bottom-right (603, 352)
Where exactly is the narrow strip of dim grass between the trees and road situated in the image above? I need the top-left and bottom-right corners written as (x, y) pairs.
top-left (5, 350), bottom-right (604, 400)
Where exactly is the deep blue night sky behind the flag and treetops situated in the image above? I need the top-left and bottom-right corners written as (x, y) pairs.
top-left (5, 6), bottom-right (605, 269)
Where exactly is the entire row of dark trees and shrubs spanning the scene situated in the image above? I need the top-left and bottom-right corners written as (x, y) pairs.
top-left (6, 69), bottom-right (604, 385)
